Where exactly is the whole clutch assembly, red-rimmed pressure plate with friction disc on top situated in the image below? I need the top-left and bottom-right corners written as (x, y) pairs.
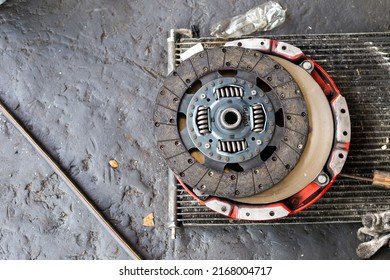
top-left (154, 39), bottom-right (350, 221)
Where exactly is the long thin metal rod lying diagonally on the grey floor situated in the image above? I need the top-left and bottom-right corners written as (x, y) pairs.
top-left (0, 101), bottom-right (142, 260)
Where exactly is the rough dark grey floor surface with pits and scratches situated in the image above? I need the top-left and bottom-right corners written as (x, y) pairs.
top-left (0, 0), bottom-right (390, 259)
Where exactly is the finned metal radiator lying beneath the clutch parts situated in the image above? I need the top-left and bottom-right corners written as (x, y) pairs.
top-left (168, 32), bottom-right (390, 226)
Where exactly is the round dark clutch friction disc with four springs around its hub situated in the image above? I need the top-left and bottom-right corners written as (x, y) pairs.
top-left (154, 47), bottom-right (309, 198)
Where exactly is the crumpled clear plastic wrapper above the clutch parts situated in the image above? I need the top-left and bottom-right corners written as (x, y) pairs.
top-left (211, 1), bottom-right (286, 38)
